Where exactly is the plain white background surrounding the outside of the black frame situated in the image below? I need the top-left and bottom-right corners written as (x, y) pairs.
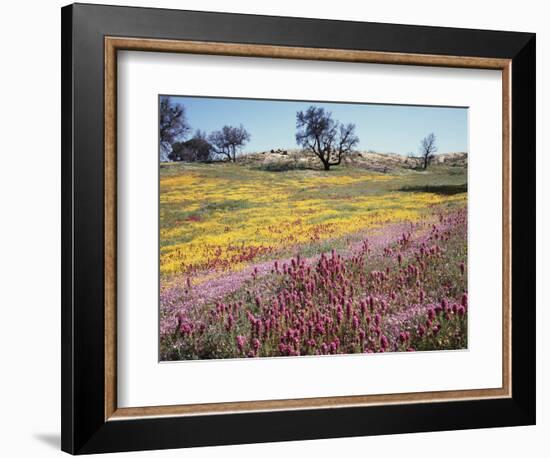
top-left (0, 0), bottom-right (550, 458)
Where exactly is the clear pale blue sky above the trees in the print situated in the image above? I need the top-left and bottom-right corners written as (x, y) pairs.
top-left (164, 96), bottom-right (468, 154)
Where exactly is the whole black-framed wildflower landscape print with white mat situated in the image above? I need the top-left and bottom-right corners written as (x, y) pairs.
top-left (62, 4), bottom-right (535, 454)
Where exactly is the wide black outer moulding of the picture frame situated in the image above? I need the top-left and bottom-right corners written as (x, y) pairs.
top-left (61, 4), bottom-right (536, 454)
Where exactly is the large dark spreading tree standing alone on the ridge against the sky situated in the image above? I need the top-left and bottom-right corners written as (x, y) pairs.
top-left (296, 106), bottom-right (359, 170)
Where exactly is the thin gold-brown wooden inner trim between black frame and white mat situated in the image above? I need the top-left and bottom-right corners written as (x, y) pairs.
top-left (104, 37), bottom-right (512, 421)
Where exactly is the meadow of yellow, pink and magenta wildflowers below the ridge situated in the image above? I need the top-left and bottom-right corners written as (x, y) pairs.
top-left (160, 162), bottom-right (468, 361)
